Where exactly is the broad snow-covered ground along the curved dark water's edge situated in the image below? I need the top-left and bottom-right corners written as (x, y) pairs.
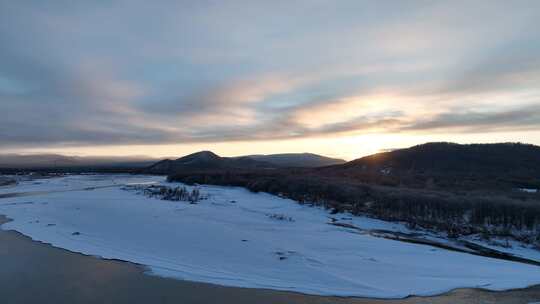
top-left (0, 175), bottom-right (540, 298)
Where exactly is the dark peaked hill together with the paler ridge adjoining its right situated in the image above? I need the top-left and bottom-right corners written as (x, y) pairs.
top-left (145, 151), bottom-right (345, 174)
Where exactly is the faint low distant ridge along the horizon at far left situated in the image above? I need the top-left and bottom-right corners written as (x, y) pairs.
top-left (0, 154), bottom-right (155, 169)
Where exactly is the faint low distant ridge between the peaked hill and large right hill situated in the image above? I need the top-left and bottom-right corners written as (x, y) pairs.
top-left (247, 153), bottom-right (345, 168)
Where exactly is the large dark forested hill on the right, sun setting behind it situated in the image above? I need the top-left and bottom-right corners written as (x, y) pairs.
top-left (318, 143), bottom-right (540, 190)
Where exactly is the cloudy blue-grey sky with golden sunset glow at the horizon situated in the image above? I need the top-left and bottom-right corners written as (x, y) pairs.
top-left (0, 0), bottom-right (540, 160)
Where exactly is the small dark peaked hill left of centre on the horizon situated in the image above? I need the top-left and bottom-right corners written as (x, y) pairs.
top-left (145, 151), bottom-right (274, 174)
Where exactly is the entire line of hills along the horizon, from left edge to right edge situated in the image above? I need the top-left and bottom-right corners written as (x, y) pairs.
top-left (4, 143), bottom-right (540, 190)
